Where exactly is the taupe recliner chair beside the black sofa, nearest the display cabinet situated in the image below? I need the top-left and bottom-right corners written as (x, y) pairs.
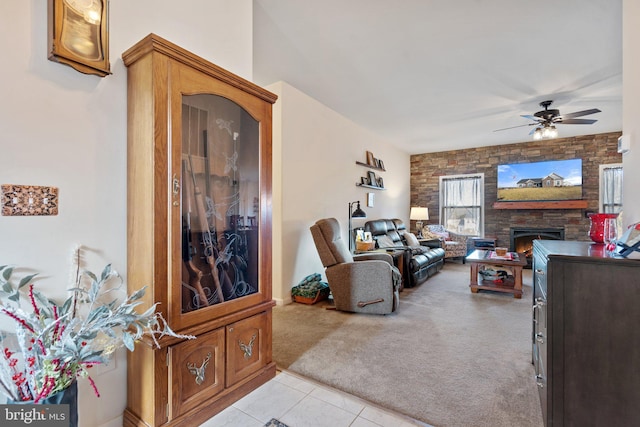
top-left (310, 218), bottom-right (402, 314)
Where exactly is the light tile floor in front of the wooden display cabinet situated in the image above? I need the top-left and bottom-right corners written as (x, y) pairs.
top-left (200, 372), bottom-right (430, 427)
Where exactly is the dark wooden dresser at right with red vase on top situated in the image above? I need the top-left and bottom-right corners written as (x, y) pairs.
top-left (532, 240), bottom-right (640, 427)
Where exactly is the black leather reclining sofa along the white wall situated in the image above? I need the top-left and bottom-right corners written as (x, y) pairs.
top-left (364, 218), bottom-right (444, 287)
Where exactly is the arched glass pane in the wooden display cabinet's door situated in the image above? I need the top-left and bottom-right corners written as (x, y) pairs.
top-left (181, 94), bottom-right (260, 313)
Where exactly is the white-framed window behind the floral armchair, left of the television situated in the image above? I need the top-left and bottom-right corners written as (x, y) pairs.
top-left (440, 174), bottom-right (484, 236)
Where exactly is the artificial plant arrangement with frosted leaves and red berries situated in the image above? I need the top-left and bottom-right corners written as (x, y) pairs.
top-left (0, 246), bottom-right (194, 403)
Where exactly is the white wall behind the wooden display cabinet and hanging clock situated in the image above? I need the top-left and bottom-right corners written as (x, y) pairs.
top-left (0, 0), bottom-right (253, 427)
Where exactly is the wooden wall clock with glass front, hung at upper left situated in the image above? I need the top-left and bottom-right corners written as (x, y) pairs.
top-left (47, 0), bottom-right (111, 77)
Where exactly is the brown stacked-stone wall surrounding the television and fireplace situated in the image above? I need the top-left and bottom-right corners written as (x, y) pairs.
top-left (411, 132), bottom-right (622, 247)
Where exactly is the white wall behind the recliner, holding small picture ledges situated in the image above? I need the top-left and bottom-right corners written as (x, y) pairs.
top-left (267, 82), bottom-right (410, 303)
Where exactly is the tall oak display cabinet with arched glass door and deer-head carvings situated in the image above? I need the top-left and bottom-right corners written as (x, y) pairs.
top-left (122, 34), bottom-right (276, 427)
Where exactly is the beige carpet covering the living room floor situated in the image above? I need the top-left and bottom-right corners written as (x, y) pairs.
top-left (273, 263), bottom-right (543, 427)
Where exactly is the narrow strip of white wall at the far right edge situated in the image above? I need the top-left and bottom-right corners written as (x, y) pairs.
top-left (622, 0), bottom-right (640, 225)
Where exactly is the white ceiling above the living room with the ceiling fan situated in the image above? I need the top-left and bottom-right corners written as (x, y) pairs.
top-left (253, 0), bottom-right (622, 154)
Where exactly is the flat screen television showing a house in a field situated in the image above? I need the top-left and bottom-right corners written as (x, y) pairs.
top-left (498, 159), bottom-right (582, 202)
